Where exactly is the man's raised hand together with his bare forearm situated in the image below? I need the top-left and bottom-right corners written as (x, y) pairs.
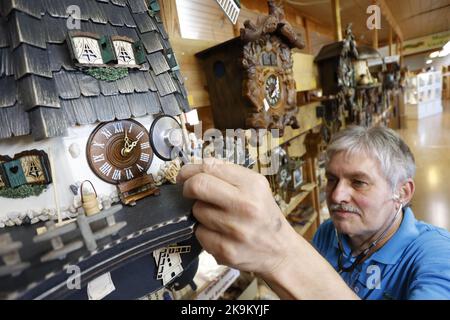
top-left (177, 159), bottom-right (357, 299)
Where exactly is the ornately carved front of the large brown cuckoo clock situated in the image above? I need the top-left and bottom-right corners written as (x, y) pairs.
top-left (241, 1), bottom-right (304, 130)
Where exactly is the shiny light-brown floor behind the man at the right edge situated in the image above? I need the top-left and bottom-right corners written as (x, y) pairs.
top-left (398, 100), bottom-right (450, 230)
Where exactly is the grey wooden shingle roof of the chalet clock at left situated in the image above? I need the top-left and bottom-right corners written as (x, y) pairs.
top-left (0, 0), bottom-right (189, 140)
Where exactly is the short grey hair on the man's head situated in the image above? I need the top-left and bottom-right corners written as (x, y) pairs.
top-left (327, 126), bottom-right (416, 190)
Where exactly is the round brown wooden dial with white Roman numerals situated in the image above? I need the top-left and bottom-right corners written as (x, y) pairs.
top-left (86, 120), bottom-right (153, 184)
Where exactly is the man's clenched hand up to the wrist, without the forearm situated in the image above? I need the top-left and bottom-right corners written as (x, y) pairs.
top-left (178, 158), bottom-right (293, 276)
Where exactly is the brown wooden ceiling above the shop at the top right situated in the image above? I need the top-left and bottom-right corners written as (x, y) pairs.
top-left (284, 0), bottom-right (450, 46)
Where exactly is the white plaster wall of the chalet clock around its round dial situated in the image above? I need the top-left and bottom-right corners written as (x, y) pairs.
top-left (0, 116), bottom-right (163, 220)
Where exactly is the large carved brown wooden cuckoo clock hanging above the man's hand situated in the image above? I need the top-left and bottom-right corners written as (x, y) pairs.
top-left (196, 1), bottom-right (304, 130)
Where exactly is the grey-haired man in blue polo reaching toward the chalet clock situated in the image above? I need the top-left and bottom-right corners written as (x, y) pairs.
top-left (179, 127), bottom-right (450, 299)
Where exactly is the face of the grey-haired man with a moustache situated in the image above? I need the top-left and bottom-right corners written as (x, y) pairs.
top-left (326, 152), bottom-right (395, 237)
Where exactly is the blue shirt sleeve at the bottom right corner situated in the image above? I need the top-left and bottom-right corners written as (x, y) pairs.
top-left (408, 232), bottom-right (450, 300)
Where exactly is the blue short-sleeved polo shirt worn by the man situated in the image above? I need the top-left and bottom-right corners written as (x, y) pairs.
top-left (313, 208), bottom-right (450, 299)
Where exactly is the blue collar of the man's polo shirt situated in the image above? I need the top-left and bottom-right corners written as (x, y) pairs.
top-left (333, 208), bottom-right (419, 264)
